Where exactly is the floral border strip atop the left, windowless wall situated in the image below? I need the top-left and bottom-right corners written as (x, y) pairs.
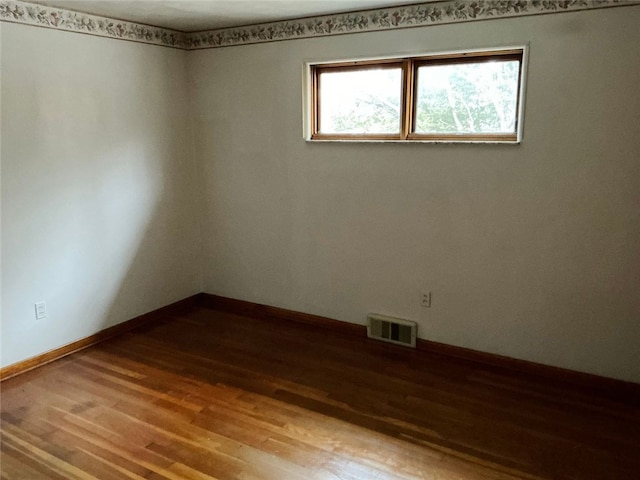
top-left (0, 0), bottom-right (186, 49)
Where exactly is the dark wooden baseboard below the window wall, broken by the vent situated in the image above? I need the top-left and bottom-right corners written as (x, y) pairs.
top-left (200, 293), bottom-right (640, 405)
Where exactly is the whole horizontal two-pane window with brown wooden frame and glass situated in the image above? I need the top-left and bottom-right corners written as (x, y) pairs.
top-left (307, 48), bottom-right (524, 143)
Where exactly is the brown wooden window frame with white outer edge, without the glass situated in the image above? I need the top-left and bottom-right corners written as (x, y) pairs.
top-left (304, 45), bottom-right (528, 144)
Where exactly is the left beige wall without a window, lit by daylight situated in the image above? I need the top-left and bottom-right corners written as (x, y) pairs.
top-left (1, 24), bottom-right (201, 366)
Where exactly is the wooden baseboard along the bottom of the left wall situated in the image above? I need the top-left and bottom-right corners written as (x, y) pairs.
top-left (0, 293), bottom-right (202, 382)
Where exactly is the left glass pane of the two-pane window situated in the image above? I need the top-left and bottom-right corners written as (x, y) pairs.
top-left (319, 67), bottom-right (402, 134)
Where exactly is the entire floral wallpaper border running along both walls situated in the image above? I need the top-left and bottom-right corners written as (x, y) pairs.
top-left (0, 0), bottom-right (640, 50)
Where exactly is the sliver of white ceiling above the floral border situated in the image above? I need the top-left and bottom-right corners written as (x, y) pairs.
top-left (28, 0), bottom-right (426, 32)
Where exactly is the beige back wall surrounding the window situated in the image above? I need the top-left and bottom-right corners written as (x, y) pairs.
top-left (187, 7), bottom-right (640, 382)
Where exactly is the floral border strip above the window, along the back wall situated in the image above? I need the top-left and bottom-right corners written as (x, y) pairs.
top-left (186, 0), bottom-right (640, 50)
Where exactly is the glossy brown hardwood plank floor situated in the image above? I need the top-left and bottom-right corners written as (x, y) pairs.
top-left (0, 308), bottom-right (640, 480)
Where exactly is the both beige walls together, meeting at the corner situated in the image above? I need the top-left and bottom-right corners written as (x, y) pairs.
top-left (0, 7), bottom-right (640, 382)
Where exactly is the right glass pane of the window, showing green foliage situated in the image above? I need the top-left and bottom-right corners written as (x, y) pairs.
top-left (415, 60), bottom-right (520, 134)
